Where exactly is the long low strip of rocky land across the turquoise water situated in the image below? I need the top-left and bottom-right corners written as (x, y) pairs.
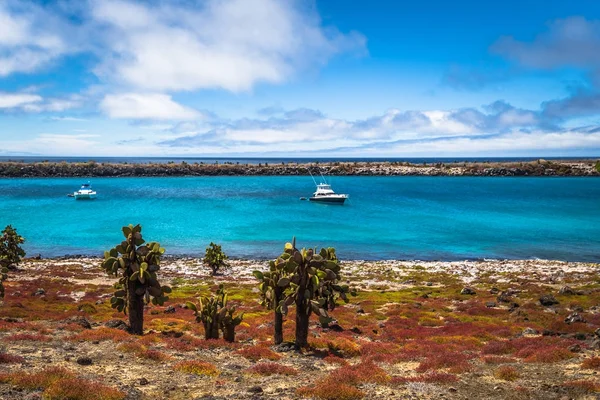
top-left (0, 159), bottom-right (600, 178)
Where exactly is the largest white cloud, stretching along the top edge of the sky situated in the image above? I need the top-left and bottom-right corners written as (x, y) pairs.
top-left (92, 0), bottom-right (364, 92)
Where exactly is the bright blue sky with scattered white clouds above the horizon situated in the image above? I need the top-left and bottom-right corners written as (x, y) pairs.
top-left (0, 0), bottom-right (600, 157)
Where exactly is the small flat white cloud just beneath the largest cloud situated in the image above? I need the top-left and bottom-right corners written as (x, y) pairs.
top-left (100, 93), bottom-right (202, 120)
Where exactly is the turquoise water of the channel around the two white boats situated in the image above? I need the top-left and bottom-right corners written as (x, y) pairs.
top-left (0, 176), bottom-right (600, 261)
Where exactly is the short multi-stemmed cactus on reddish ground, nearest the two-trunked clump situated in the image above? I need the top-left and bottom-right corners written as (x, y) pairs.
top-left (186, 284), bottom-right (244, 342)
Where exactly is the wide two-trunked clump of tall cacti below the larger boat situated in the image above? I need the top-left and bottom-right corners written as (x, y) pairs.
top-left (254, 238), bottom-right (356, 347)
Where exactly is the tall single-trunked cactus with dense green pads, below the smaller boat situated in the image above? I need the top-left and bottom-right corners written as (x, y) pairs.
top-left (102, 225), bottom-right (171, 335)
